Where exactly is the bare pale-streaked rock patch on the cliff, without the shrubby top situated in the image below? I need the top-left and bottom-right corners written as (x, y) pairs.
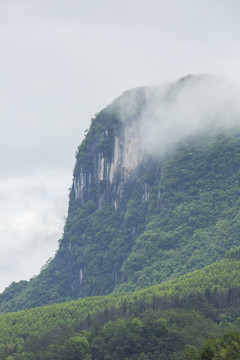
top-left (72, 123), bottom-right (143, 208)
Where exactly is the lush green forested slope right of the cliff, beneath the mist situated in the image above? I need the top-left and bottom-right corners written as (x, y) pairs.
top-left (118, 134), bottom-right (240, 289)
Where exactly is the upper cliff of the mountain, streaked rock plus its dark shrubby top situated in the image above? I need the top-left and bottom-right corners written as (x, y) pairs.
top-left (70, 89), bottom-right (143, 209)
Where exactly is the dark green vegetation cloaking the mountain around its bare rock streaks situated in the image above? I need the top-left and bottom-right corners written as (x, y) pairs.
top-left (0, 116), bottom-right (240, 312)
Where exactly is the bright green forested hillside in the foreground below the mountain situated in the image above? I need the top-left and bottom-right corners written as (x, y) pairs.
top-left (0, 258), bottom-right (240, 360)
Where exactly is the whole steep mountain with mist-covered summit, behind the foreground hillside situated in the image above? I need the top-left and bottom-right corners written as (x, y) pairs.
top-left (0, 75), bottom-right (240, 312)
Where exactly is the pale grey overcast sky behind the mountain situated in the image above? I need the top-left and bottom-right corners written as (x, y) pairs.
top-left (0, 0), bottom-right (240, 290)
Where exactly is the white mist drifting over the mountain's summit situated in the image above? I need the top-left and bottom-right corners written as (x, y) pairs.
top-left (132, 75), bottom-right (240, 155)
